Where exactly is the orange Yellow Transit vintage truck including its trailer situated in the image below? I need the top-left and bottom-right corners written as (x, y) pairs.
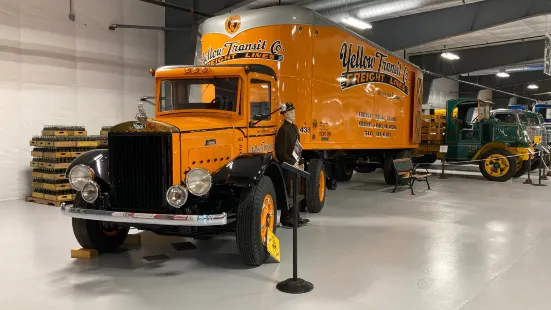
top-left (63, 6), bottom-right (423, 265)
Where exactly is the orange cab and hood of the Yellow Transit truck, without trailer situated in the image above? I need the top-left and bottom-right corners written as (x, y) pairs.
top-left (62, 65), bottom-right (314, 266)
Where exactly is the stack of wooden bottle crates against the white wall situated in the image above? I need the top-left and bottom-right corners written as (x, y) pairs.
top-left (27, 125), bottom-right (98, 206)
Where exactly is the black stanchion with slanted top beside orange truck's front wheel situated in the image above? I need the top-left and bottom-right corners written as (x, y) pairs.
top-left (276, 163), bottom-right (314, 294)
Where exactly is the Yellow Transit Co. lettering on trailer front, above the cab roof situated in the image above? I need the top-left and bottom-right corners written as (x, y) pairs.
top-left (202, 40), bottom-right (285, 65)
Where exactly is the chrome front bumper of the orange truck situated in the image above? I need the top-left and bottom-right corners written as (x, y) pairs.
top-left (61, 205), bottom-right (228, 226)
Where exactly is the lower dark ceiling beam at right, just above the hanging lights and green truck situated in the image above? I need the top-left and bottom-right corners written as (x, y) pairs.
top-left (409, 40), bottom-right (545, 76)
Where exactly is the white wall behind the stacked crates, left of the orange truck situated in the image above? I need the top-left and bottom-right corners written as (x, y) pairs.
top-left (0, 0), bottom-right (164, 200)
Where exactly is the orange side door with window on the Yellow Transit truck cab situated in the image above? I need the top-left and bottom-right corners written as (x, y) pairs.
top-left (247, 77), bottom-right (279, 153)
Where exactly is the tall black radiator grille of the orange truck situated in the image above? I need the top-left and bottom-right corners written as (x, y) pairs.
top-left (108, 133), bottom-right (172, 212)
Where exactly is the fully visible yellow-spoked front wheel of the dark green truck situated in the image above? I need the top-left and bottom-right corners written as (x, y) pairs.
top-left (478, 149), bottom-right (517, 182)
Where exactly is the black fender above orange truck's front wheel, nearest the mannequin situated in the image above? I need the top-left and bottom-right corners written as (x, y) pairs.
top-left (212, 153), bottom-right (288, 209)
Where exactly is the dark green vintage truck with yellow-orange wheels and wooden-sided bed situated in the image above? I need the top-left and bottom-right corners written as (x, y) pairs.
top-left (411, 98), bottom-right (534, 182)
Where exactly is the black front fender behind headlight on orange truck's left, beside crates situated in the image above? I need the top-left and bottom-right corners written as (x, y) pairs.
top-left (65, 149), bottom-right (111, 192)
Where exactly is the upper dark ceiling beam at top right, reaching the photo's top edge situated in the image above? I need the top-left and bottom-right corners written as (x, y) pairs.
top-left (363, 0), bottom-right (551, 51)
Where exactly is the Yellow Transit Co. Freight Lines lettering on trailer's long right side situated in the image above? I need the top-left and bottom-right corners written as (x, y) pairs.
top-left (339, 42), bottom-right (409, 95)
